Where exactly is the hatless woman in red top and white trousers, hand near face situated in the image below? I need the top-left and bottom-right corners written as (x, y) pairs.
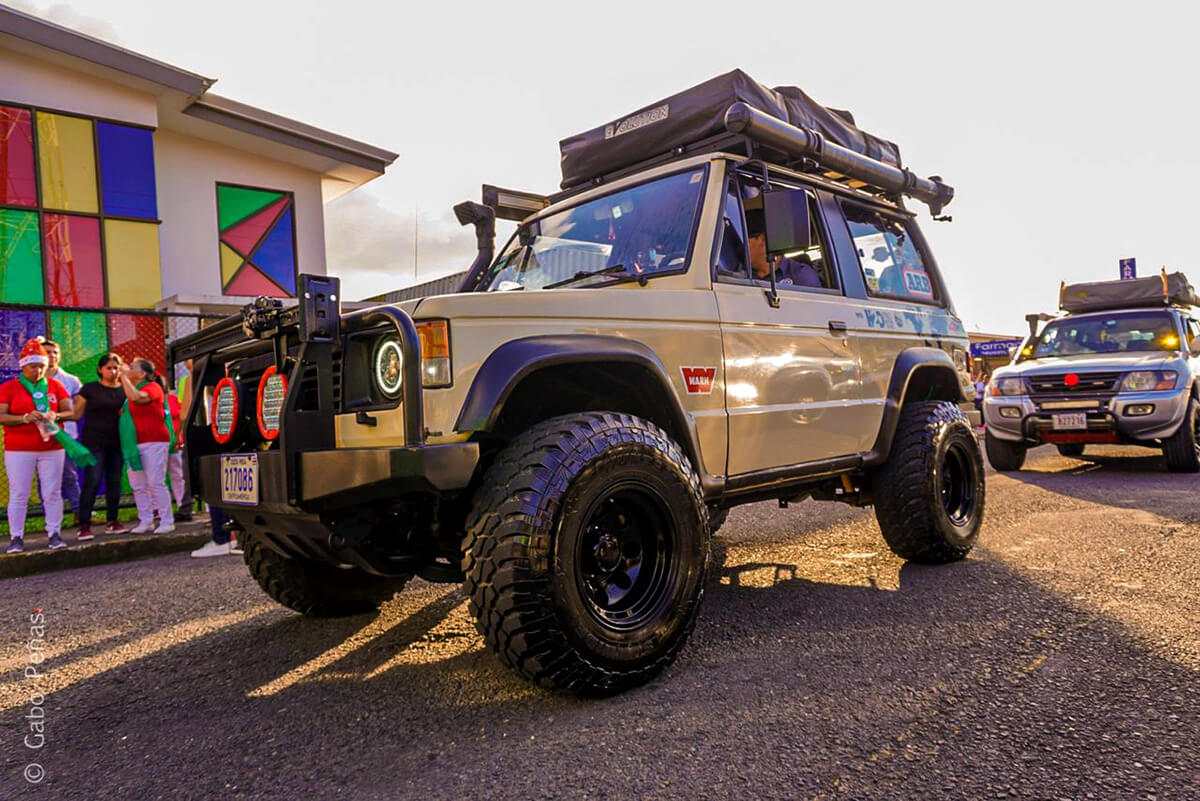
top-left (118, 357), bottom-right (175, 534)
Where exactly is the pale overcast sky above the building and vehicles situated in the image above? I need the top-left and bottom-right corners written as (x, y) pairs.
top-left (16, 0), bottom-right (1200, 333)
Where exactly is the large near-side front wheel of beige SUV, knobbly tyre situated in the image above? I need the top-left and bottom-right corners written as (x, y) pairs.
top-left (463, 412), bottom-right (709, 695)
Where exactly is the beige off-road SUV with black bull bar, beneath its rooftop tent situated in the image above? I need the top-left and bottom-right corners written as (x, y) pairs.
top-left (172, 71), bottom-right (984, 694)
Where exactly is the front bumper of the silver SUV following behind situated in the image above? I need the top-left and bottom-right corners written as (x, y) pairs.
top-left (983, 387), bottom-right (1190, 445)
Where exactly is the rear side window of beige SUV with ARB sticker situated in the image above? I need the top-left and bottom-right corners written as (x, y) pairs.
top-left (841, 203), bottom-right (940, 303)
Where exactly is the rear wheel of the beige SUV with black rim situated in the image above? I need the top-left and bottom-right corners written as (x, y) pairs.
top-left (871, 401), bottom-right (984, 565)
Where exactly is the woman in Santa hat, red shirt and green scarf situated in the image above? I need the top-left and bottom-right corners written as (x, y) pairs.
top-left (0, 337), bottom-right (72, 554)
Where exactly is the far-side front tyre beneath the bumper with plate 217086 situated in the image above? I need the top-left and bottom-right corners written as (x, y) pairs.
top-left (242, 532), bottom-right (410, 618)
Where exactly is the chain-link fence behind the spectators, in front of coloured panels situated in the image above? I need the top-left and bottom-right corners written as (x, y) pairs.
top-left (0, 303), bottom-right (229, 519)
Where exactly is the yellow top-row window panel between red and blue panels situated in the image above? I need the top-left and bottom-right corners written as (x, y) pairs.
top-left (37, 112), bottom-right (100, 213)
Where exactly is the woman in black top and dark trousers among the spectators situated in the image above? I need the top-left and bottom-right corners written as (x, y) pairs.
top-left (74, 354), bottom-right (126, 540)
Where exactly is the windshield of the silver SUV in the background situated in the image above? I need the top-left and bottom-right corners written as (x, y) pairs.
top-left (1030, 312), bottom-right (1180, 359)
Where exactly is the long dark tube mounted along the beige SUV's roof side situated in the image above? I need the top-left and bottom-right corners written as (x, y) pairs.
top-left (725, 102), bottom-right (954, 216)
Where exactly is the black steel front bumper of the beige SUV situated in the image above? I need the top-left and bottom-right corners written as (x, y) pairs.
top-left (198, 442), bottom-right (479, 517)
